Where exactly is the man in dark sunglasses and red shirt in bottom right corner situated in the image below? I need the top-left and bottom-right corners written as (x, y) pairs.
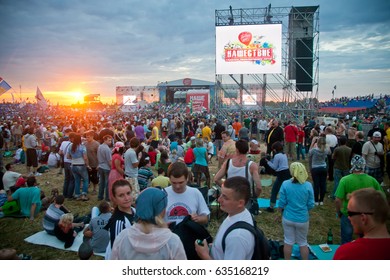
top-left (333, 188), bottom-right (390, 260)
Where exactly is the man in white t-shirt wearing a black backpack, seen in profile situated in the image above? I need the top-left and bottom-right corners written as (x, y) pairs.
top-left (195, 176), bottom-right (255, 260)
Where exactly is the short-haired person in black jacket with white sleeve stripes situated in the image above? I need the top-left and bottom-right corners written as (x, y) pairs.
top-left (104, 179), bottom-right (135, 260)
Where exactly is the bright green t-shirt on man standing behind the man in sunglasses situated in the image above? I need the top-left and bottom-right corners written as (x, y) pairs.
top-left (335, 173), bottom-right (383, 215)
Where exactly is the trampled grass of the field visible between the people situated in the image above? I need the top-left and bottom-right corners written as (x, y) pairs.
top-left (0, 151), bottom-right (390, 260)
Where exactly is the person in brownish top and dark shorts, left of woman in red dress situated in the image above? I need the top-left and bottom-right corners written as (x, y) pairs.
top-left (84, 130), bottom-right (100, 194)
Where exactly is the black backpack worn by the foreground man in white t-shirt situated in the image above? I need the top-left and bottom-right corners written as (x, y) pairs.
top-left (222, 219), bottom-right (271, 260)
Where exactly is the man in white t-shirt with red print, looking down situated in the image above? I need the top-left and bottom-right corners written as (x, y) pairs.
top-left (165, 162), bottom-right (210, 225)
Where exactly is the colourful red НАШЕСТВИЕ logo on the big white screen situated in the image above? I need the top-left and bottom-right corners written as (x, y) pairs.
top-left (222, 31), bottom-right (276, 65)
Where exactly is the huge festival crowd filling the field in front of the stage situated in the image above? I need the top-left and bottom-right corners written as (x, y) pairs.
top-left (0, 102), bottom-right (390, 259)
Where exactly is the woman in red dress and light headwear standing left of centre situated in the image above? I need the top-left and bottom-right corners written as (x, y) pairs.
top-left (108, 142), bottom-right (125, 201)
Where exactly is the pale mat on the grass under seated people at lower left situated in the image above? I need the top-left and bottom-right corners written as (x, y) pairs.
top-left (24, 230), bottom-right (105, 257)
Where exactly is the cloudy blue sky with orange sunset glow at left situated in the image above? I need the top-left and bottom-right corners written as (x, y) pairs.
top-left (0, 0), bottom-right (390, 103)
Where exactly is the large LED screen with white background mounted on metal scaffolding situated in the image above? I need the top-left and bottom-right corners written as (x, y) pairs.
top-left (216, 24), bottom-right (282, 75)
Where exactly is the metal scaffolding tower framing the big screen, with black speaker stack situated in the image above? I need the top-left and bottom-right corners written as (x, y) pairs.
top-left (215, 4), bottom-right (320, 119)
